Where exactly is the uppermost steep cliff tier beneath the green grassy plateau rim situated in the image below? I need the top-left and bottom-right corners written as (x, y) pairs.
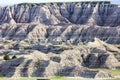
top-left (0, 3), bottom-right (120, 26)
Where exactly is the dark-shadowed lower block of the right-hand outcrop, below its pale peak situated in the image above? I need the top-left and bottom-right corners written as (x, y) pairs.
top-left (84, 53), bottom-right (120, 69)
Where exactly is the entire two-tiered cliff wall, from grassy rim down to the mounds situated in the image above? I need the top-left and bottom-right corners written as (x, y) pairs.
top-left (0, 3), bottom-right (120, 43)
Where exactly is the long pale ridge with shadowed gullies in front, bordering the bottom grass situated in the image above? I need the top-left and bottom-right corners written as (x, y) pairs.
top-left (0, 51), bottom-right (112, 78)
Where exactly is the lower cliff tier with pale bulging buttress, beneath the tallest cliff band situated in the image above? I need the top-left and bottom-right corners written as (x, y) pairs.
top-left (0, 23), bottom-right (120, 44)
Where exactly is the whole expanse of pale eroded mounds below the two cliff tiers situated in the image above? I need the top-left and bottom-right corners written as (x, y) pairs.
top-left (0, 39), bottom-right (120, 78)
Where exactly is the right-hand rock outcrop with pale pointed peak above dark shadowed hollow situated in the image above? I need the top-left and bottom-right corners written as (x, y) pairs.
top-left (84, 38), bottom-right (120, 68)
